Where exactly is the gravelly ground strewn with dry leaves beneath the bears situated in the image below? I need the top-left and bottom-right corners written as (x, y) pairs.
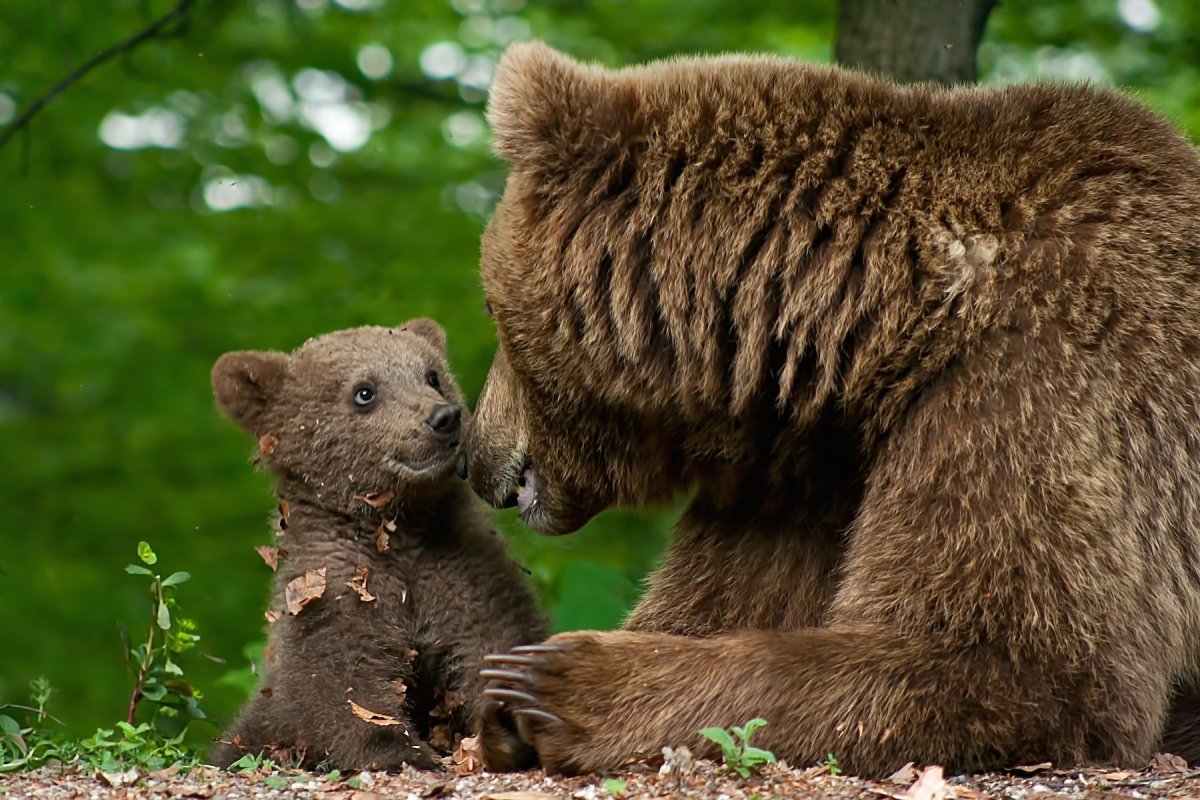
top-left (7, 756), bottom-right (1200, 800)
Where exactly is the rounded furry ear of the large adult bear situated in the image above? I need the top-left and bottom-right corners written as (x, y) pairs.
top-left (487, 42), bottom-right (637, 168)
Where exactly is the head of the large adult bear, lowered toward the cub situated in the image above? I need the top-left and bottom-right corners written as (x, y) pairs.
top-left (461, 43), bottom-right (686, 534)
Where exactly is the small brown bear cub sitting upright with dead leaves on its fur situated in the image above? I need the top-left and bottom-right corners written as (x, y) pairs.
top-left (209, 319), bottom-right (545, 770)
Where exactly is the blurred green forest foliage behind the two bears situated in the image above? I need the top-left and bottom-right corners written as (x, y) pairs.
top-left (0, 0), bottom-right (1200, 733)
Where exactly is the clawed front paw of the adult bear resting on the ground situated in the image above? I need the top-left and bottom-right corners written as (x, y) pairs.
top-left (480, 631), bottom-right (654, 774)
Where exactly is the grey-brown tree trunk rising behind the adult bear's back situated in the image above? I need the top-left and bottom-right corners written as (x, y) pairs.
top-left (835, 0), bottom-right (997, 84)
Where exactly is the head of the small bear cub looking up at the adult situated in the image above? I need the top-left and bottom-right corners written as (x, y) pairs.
top-left (212, 319), bottom-right (463, 512)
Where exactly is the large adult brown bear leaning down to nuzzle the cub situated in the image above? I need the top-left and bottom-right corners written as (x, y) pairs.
top-left (466, 43), bottom-right (1200, 775)
